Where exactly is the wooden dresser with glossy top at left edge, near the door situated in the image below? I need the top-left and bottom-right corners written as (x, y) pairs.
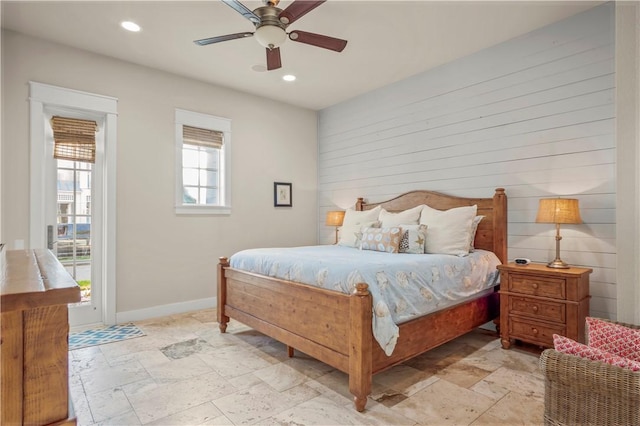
top-left (0, 250), bottom-right (80, 425)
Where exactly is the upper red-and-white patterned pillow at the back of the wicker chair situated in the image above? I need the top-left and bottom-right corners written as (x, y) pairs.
top-left (587, 317), bottom-right (640, 362)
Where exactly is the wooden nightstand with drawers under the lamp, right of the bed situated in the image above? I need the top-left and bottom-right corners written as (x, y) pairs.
top-left (498, 263), bottom-right (592, 349)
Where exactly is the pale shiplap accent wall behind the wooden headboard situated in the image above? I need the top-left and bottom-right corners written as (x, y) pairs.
top-left (318, 3), bottom-right (616, 318)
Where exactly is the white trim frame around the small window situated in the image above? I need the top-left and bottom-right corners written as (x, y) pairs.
top-left (175, 108), bottom-right (231, 215)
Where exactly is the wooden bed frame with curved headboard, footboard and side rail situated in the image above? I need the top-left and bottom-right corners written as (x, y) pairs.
top-left (217, 188), bottom-right (507, 411)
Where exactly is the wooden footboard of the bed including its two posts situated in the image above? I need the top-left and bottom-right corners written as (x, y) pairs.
top-left (217, 257), bottom-right (373, 411)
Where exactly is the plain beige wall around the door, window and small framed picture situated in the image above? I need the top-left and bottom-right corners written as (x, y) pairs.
top-left (0, 31), bottom-right (318, 319)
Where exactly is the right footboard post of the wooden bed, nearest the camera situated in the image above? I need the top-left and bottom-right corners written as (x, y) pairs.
top-left (349, 283), bottom-right (373, 411)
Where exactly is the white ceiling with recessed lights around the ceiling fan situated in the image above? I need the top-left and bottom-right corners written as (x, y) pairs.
top-left (2, 0), bottom-right (601, 110)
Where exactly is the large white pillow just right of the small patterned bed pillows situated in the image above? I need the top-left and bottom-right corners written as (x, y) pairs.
top-left (420, 205), bottom-right (478, 256)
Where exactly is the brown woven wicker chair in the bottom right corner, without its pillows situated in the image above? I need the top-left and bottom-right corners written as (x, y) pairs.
top-left (540, 323), bottom-right (640, 425)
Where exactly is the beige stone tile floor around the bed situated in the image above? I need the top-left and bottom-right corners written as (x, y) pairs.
top-left (69, 310), bottom-right (544, 425)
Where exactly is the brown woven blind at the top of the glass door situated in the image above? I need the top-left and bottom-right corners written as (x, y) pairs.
top-left (51, 116), bottom-right (98, 163)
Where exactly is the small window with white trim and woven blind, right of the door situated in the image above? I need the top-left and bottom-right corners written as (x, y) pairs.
top-left (176, 109), bottom-right (231, 214)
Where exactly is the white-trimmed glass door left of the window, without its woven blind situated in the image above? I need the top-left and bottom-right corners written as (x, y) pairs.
top-left (29, 82), bottom-right (117, 327)
